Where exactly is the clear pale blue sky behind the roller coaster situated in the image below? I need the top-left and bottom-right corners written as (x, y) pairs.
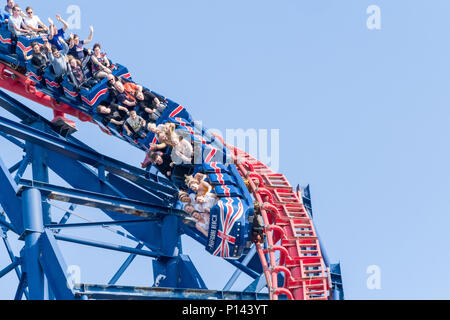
top-left (0, 0), bottom-right (450, 299)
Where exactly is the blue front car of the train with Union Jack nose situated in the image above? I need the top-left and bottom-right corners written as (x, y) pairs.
top-left (203, 163), bottom-right (255, 259)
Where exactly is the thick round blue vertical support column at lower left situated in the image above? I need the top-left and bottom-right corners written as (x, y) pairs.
top-left (22, 189), bottom-right (44, 300)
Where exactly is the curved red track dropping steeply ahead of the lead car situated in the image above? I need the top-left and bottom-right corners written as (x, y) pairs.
top-left (214, 132), bottom-right (331, 300)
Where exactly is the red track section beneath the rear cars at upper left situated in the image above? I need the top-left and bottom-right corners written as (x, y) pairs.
top-left (0, 63), bottom-right (92, 122)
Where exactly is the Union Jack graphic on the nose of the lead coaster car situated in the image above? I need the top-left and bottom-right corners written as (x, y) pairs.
top-left (213, 198), bottom-right (244, 258)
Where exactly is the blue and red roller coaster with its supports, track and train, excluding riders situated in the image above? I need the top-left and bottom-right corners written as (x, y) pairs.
top-left (0, 8), bottom-right (344, 300)
